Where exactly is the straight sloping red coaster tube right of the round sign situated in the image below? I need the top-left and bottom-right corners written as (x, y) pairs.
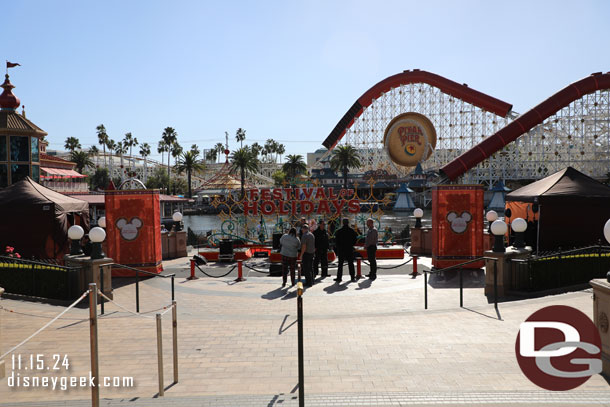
top-left (441, 72), bottom-right (610, 180)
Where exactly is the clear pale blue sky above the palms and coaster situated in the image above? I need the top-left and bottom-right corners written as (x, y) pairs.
top-left (1, 0), bottom-right (610, 164)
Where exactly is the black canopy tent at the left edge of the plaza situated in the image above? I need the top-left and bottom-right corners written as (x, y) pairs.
top-left (0, 177), bottom-right (89, 259)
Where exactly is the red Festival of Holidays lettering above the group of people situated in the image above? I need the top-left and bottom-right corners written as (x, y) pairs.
top-left (243, 187), bottom-right (360, 216)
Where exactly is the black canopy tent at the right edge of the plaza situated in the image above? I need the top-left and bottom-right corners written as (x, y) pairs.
top-left (506, 167), bottom-right (610, 250)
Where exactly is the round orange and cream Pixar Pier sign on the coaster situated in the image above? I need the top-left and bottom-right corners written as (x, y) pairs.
top-left (383, 112), bottom-right (436, 167)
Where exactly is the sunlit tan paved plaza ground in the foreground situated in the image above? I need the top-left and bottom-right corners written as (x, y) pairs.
top-left (0, 259), bottom-right (610, 406)
